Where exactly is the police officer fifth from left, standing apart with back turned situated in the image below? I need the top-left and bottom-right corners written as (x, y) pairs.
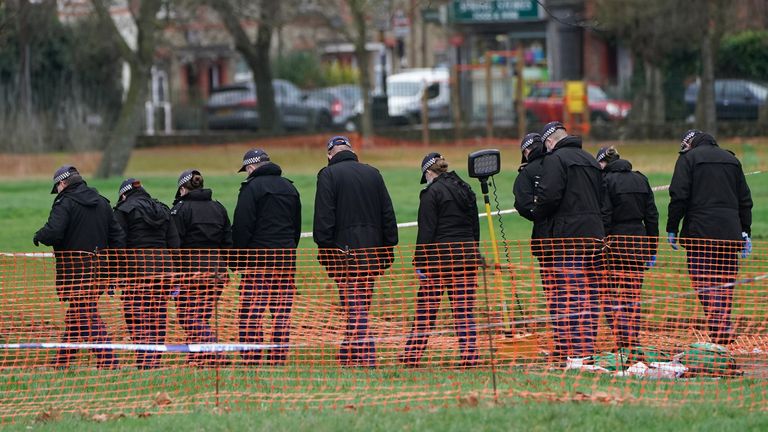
top-left (313, 136), bottom-right (398, 367)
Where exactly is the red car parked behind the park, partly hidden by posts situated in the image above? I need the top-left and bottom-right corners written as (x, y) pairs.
top-left (525, 81), bottom-right (632, 123)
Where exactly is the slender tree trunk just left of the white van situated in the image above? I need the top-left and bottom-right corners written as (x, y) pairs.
top-left (348, 0), bottom-right (373, 147)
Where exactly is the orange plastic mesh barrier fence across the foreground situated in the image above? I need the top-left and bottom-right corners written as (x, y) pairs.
top-left (0, 237), bottom-right (768, 422)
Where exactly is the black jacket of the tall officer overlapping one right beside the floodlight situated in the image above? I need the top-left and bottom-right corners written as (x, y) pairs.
top-left (533, 136), bottom-right (605, 243)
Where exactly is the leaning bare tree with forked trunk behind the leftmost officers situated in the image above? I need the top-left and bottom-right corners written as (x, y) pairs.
top-left (91, 0), bottom-right (163, 178)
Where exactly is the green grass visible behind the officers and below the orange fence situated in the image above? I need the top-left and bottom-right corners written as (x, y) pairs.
top-left (0, 141), bottom-right (768, 431)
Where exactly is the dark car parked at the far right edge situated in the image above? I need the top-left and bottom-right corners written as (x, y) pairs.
top-left (685, 79), bottom-right (768, 120)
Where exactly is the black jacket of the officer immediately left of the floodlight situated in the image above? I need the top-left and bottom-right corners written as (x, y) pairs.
top-left (413, 171), bottom-right (480, 272)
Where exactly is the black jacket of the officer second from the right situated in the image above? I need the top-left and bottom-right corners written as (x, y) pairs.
top-left (603, 159), bottom-right (659, 261)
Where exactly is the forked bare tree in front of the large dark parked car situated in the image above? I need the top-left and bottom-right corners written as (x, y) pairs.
top-left (208, 0), bottom-right (283, 132)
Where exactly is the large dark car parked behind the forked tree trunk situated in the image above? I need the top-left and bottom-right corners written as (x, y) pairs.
top-left (205, 79), bottom-right (332, 129)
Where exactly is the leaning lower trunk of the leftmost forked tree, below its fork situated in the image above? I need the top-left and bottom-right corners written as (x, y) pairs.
top-left (96, 62), bottom-right (152, 178)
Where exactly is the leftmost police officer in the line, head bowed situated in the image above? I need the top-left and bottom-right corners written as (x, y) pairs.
top-left (32, 165), bottom-right (125, 369)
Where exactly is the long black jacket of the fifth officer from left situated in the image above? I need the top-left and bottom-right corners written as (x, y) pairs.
top-left (313, 151), bottom-right (398, 271)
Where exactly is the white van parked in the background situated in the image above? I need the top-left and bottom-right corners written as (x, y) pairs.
top-left (387, 69), bottom-right (451, 123)
